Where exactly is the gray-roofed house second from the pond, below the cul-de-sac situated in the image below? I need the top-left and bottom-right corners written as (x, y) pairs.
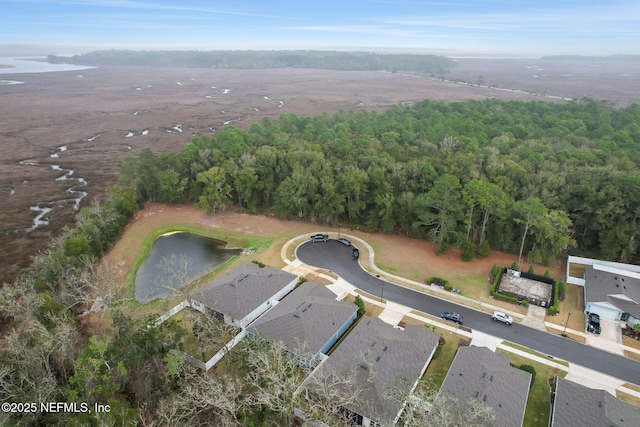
top-left (249, 282), bottom-right (358, 366)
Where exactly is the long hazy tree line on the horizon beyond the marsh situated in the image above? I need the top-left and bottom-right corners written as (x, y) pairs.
top-left (48, 50), bottom-right (455, 74)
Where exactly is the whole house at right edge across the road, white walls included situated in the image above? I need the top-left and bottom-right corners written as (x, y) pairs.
top-left (584, 264), bottom-right (640, 327)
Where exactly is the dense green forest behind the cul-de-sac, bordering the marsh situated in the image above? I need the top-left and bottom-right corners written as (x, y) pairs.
top-left (122, 99), bottom-right (640, 264)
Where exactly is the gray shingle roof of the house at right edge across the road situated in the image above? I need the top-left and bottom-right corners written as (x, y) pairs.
top-left (584, 267), bottom-right (640, 319)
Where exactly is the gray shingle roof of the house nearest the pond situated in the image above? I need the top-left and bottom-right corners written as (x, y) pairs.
top-left (191, 263), bottom-right (297, 319)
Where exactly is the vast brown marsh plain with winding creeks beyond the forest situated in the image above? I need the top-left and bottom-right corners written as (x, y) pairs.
top-left (0, 59), bottom-right (640, 282)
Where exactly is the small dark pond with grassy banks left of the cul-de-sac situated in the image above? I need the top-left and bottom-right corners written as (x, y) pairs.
top-left (136, 233), bottom-right (240, 302)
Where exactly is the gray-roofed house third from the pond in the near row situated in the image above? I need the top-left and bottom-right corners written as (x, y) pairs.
top-left (308, 317), bottom-right (440, 426)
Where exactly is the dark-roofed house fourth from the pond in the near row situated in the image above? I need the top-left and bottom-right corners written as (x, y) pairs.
top-left (441, 346), bottom-right (531, 427)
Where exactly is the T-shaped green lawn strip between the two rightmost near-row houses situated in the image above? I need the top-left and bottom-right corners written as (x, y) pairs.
top-left (496, 348), bottom-right (567, 427)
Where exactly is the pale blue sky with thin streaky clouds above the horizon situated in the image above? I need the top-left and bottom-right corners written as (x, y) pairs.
top-left (0, 0), bottom-right (640, 55)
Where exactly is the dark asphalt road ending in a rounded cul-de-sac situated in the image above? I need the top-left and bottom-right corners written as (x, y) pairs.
top-left (296, 240), bottom-right (640, 384)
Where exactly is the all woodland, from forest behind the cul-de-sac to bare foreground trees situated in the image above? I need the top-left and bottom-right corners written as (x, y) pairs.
top-left (0, 95), bottom-right (640, 425)
